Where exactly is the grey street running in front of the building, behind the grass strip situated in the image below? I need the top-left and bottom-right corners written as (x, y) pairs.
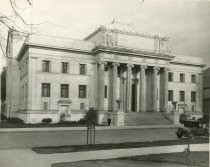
top-left (0, 128), bottom-right (177, 149)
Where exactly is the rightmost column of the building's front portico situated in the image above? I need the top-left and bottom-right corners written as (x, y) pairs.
top-left (163, 68), bottom-right (169, 112)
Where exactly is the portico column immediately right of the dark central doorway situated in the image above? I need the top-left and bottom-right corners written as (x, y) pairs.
top-left (139, 66), bottom-right (147, 112)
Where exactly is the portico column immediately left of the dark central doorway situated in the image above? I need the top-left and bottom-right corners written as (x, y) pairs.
top-left (126, 64), bottom-right (133, 112)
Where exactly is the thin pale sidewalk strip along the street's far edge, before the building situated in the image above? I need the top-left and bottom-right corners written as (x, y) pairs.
top-left (0, 125), bottom-right (179, 133)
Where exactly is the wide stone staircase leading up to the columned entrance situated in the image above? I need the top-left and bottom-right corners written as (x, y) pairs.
top-left (124, 112), bottom-right (173, 126)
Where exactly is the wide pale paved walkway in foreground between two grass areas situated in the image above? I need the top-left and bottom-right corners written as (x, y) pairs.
top-left (0, 144), bottom-right (209, 167)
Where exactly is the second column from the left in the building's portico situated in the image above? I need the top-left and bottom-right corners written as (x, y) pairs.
top-left (112, 63), bottom-right (120, 111)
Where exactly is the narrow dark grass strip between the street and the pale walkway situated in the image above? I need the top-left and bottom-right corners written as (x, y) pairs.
top-left (32, 138), bottom-right (209, 154)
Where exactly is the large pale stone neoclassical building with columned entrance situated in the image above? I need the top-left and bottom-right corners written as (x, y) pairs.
top-left (6, 22), bottom-right (204, 125)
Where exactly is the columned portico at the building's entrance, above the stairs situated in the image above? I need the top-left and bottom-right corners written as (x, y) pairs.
top-left (96, 60), bottom-right (168, 113)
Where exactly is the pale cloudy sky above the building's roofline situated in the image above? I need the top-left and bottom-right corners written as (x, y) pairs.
top-left (0, 0), bottom-right (210, 70)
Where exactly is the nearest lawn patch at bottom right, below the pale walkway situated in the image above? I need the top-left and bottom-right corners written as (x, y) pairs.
top-left (52, 152), bottom-right (209, 167)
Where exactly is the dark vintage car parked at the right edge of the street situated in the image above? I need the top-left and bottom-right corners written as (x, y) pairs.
top-left (176, 120), bottom-right (209, 139)
